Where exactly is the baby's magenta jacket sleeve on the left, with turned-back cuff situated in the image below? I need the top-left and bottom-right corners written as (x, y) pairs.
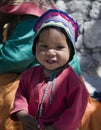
top-left (10, 72), bottom-right (28, 121)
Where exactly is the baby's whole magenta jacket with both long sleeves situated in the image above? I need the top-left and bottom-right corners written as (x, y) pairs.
top-left (10, 66), bottom-right (88, 130)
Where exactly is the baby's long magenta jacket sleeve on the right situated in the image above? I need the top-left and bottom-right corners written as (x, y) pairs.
top-left (53, 73), bottom-right (88, 130)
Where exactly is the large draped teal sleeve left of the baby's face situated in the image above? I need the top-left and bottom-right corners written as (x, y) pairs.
top-left (0, 16), bottom-right (37, 73)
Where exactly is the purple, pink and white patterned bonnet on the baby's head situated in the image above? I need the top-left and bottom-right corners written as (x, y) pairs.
top-left (33, 9), bottom-right (78, 45)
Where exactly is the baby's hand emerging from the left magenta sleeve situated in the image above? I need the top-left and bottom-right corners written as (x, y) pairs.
top-left (17, 111), bottom-right (37, 130)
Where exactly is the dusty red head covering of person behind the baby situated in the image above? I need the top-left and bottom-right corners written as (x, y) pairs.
top-left (0, 0), bottom-right (55, 16)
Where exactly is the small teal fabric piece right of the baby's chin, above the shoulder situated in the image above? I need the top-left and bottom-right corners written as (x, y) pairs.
top-left (69, 53), bottom-right (81, 76)
